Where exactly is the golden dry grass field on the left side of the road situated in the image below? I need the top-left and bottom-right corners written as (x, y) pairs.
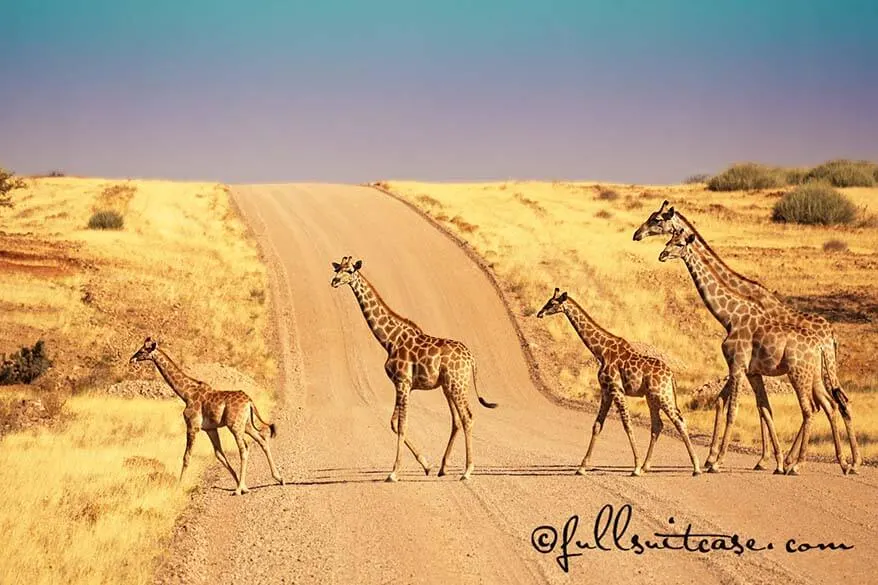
top-left (0, 178), bottom-right (274, 584)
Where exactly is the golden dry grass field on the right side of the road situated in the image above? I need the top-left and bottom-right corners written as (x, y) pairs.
top-left (387, 182), bottom-right (878, 458)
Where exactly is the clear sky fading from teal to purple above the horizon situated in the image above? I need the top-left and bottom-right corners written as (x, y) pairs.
top-left (0, 0), bottom-right (878, 183)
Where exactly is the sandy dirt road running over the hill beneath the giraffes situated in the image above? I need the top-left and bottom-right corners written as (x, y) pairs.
top-left (160, 185), bottom-right (878, 584)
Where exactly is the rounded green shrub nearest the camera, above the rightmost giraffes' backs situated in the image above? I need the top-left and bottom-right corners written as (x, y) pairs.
top-left (771, 183), bottom-right (857, 225)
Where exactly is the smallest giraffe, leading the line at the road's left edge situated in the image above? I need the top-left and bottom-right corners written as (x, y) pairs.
top-left (129, 337), bottom-right (284, 495)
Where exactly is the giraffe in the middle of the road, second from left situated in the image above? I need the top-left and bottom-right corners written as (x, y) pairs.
top-left (330, 256), bottom-right (497, 482)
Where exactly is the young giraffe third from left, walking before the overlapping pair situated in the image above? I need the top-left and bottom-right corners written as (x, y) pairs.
top-left (537, 288), bottom-right (701, 476)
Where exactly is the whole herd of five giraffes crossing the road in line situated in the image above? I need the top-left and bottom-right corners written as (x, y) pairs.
top-left (131, 201), bottom-right (862, 494)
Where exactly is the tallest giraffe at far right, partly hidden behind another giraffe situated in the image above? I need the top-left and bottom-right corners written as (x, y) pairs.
top-left (634, 200), bottom-right (862, 472)
